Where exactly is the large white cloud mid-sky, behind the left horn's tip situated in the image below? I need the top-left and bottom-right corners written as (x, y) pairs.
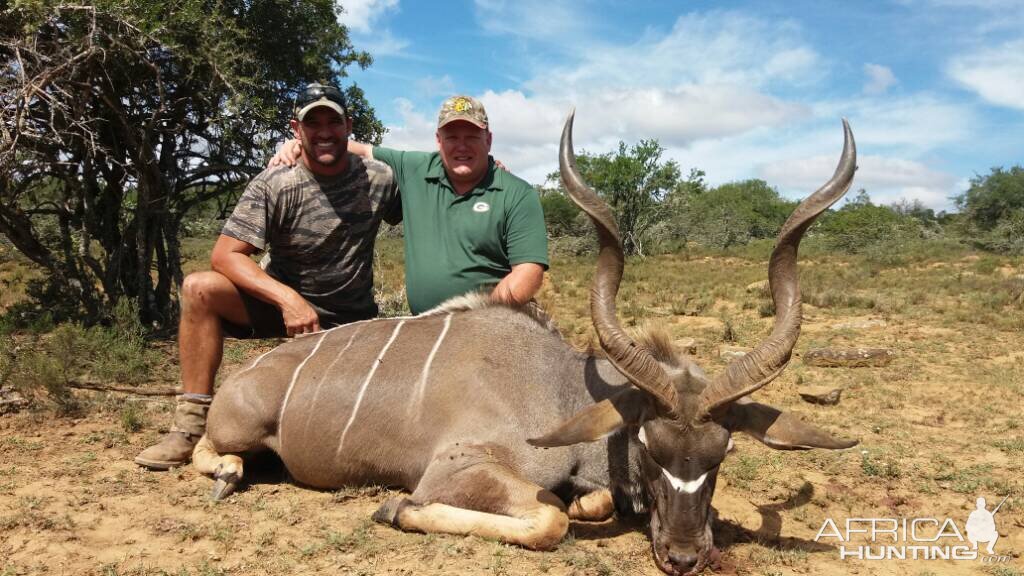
top-left (468, 10), bottom-right (822, 175)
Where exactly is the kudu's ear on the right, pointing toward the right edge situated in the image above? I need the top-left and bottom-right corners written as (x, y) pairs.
top-left (722, 399), bottom-right (858, 450)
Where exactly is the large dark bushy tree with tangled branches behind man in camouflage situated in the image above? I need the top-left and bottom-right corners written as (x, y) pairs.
top-left (0, 0), bottom-right (384, 324)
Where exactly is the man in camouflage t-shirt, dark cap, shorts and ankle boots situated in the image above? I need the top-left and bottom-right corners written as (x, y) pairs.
top-left (135, 84), bottom-right (401, 469)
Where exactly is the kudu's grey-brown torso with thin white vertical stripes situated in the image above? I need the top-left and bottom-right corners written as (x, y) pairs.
top-left (209, 303), bottom-right (626, 492)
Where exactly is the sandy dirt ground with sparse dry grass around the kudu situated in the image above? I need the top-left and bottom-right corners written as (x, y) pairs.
top-left (0, 252), bottom-right (1024, 576)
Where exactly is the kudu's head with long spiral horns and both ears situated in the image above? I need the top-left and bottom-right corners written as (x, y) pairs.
top-left (529, 114), bottom-right (857, 574)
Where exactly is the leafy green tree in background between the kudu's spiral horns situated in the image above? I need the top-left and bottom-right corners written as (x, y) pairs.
top-left (548, 139), bottom-right (680, 255)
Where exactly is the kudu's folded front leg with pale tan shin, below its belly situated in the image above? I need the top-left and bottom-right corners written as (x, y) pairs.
top-left (374, 447), bottom-right (569, 549)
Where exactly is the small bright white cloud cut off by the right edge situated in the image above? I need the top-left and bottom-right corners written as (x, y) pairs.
top-left (946, 39), bottom-right (1024, 110)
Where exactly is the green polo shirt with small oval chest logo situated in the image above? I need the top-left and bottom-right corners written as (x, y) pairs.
top-left (374, 147), bottom-right (548, 314)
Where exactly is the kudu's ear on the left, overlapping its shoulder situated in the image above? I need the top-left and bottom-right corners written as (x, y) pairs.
top-left (526, 388), bottom-right (654, 448)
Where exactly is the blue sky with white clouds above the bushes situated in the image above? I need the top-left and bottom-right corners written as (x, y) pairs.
top-left (341, 0), bottom-right (1024, 210)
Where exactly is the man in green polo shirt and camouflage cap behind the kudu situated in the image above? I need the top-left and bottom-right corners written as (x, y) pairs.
top-left (271, 96), bottom-right (548, 314)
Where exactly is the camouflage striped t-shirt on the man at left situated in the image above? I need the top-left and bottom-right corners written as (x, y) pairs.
top-left (222, 154), bottom-right (401, 314)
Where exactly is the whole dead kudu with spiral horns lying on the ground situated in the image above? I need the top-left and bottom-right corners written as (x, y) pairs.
top-left (195, 116), bottom-right (856, 574)
